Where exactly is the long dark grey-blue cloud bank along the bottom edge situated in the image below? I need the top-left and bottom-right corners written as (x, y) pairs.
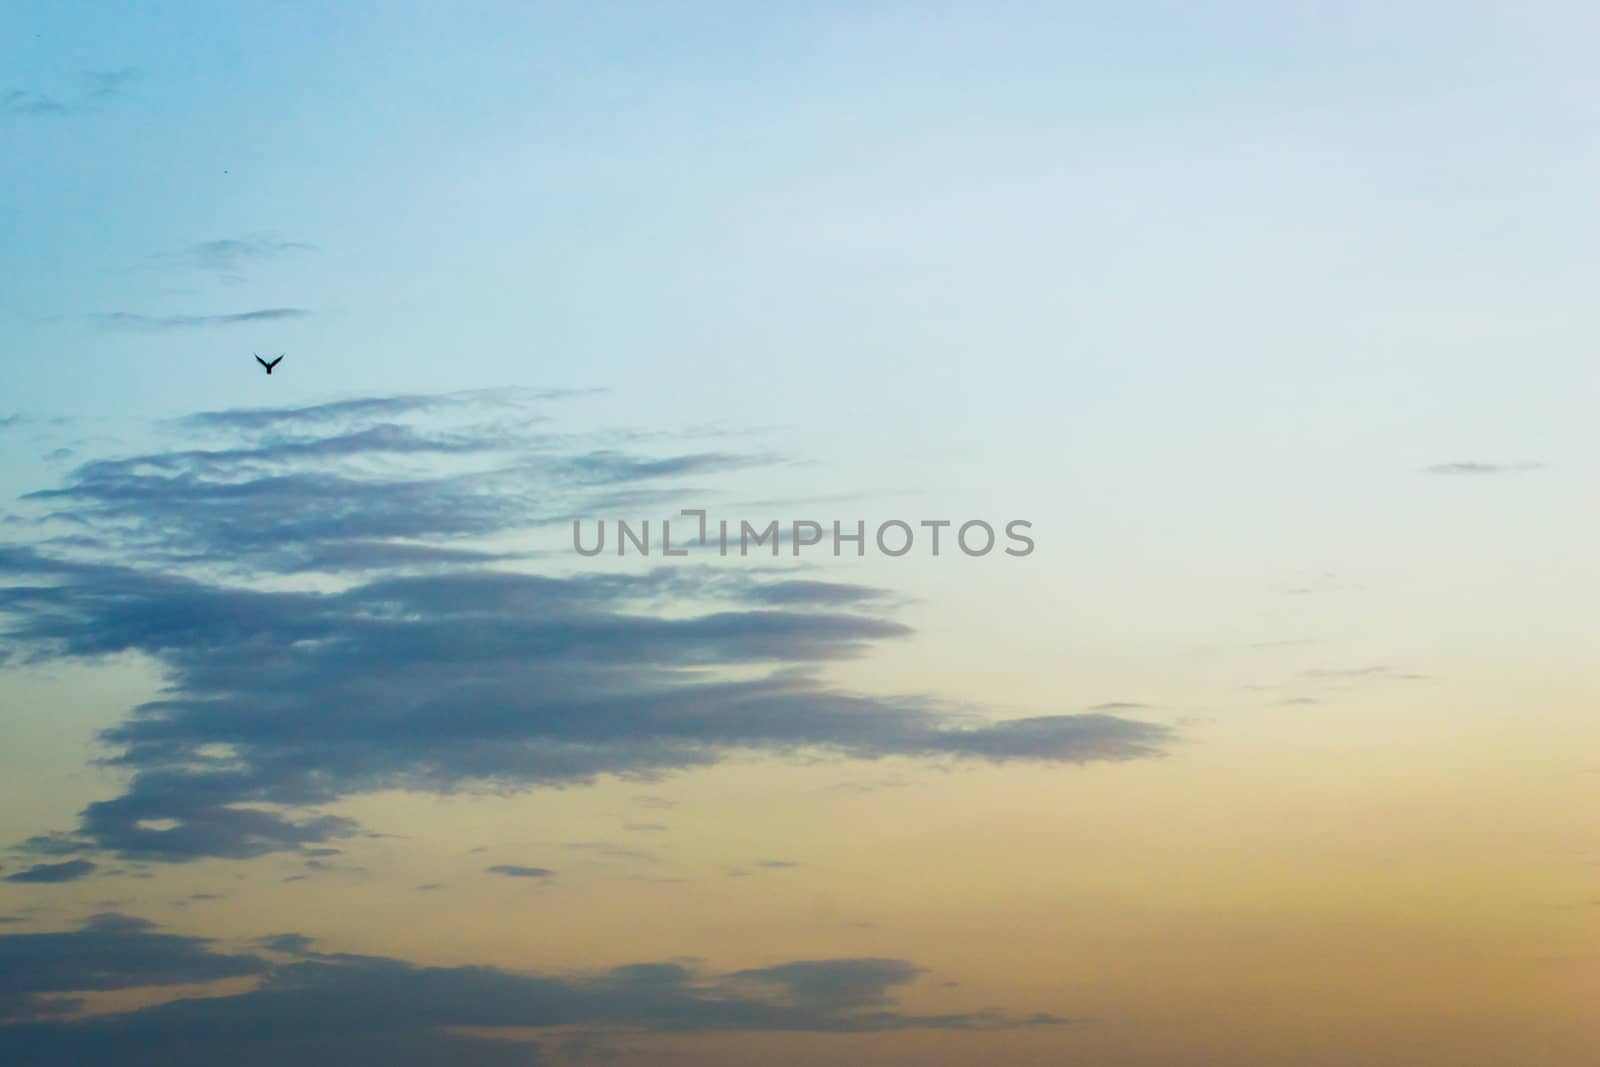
top-left (0, 915), bottom-right (1064, 1067)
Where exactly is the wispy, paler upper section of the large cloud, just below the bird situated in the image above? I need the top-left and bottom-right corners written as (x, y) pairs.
top-left (26, 397), bottom-right (766, 584)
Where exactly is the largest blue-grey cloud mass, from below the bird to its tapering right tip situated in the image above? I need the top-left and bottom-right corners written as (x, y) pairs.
top-left (0, 394), bottom-right (1168, 862)
